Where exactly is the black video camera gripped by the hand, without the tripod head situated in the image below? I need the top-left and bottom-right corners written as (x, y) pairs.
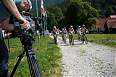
top-left (9, 12), bottom-right (35, 34)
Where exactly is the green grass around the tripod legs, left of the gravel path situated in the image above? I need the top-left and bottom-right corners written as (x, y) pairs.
top-left (5, 37), bottom-right (62, 77)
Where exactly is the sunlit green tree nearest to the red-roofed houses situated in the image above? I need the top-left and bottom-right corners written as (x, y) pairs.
top-left (81, 2), bottom-right (99, 28)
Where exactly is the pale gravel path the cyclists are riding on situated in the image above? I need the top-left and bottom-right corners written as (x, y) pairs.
top-left (58, 38), bottom-right (116, 77)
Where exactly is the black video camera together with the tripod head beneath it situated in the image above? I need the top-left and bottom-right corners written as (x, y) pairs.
top-left (9, 12), bottom-right (35, 49)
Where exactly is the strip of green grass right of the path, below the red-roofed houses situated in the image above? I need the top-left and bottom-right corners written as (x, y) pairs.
top-left (75, 34), bottom-right (116, 47)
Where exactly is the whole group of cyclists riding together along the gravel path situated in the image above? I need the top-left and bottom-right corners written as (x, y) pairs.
top-left (52, 24), bottom-right (89, 45)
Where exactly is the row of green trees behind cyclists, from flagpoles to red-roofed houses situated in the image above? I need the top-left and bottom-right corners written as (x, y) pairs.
top-left (45, 0), bottom-right (99, 28)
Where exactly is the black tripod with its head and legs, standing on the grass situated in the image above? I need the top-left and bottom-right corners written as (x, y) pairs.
top-left (10, 12), bottom-right (42, 77)
